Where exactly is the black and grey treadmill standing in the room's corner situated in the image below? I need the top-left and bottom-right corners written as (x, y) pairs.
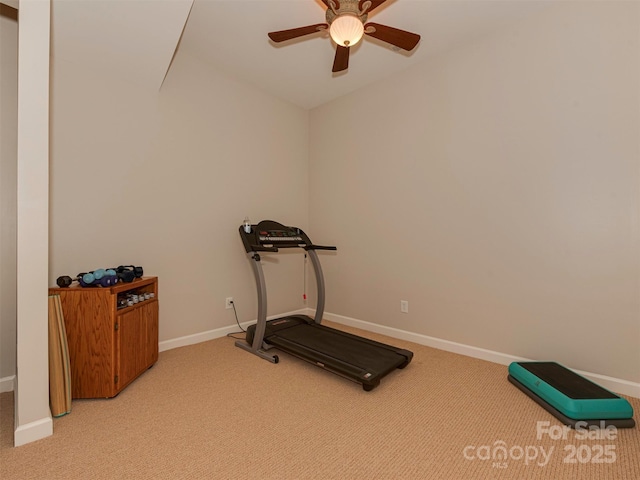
top-left (235, 220), bottom-right (413, 392)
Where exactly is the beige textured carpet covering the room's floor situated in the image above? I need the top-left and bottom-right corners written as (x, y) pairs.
top-left (0, 325), bottom-right (640, 480)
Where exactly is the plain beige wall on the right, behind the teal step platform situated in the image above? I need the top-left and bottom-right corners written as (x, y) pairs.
top-left (309, 2), bottom-right (640, 382)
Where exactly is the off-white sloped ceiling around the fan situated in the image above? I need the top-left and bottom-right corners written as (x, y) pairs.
top-left (47, 0), bottom-right (553, 109)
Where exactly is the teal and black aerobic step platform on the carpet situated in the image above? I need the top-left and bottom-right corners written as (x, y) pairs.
top-left (507, 362), bottom-right (635, 428)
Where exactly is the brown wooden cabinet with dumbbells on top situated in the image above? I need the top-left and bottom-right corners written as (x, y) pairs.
top-left (49, 277), bottom-right (158, 398)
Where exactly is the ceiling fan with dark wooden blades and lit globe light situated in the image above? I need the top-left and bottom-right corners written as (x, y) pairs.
top-left (268, 0), bottom-right (420, 72)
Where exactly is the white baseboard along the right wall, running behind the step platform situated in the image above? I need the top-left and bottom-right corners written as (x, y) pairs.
top-left (320, 309), bottom-right (640, 398)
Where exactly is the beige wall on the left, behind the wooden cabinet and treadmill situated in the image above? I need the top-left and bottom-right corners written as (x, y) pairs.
top-left (50, 47), bottom-right (308, 341)
